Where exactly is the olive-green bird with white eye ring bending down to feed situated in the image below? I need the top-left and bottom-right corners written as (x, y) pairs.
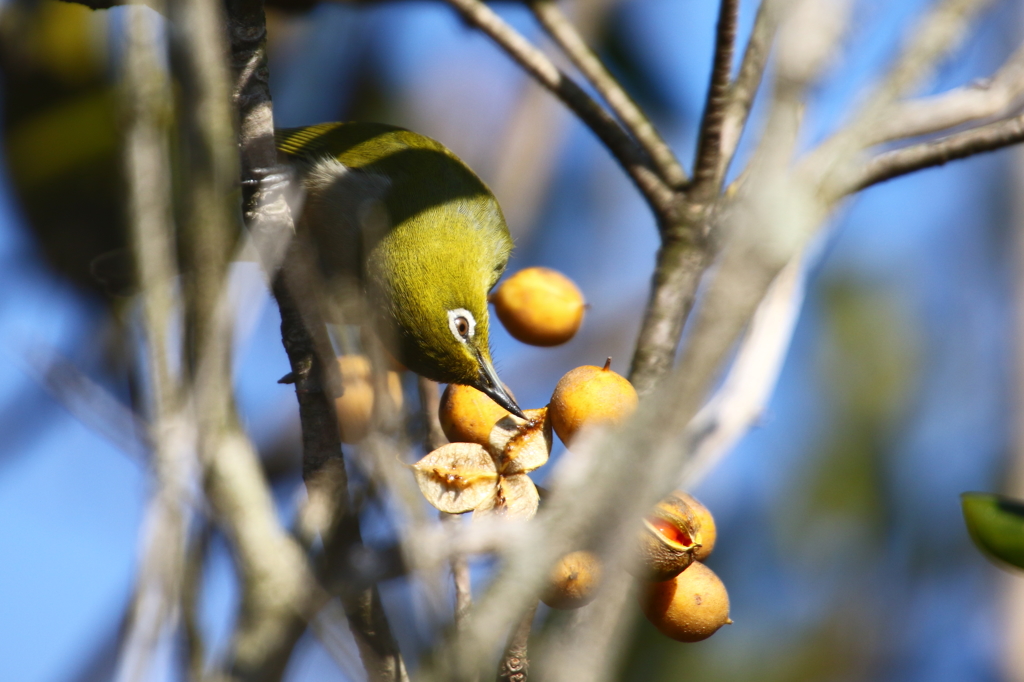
top-left (276, 123), bottom-right (523, 417)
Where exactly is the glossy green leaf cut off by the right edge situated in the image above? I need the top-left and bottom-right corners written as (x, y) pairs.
top-left (961, 493), bottom-right (1024, 568)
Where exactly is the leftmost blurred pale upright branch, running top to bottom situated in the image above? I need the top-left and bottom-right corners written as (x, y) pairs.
top-left (118, 8), bottom-right (196, 682)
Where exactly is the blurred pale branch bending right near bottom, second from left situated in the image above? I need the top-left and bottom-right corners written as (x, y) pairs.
top-left (170, 0), bottom-right (316, 681)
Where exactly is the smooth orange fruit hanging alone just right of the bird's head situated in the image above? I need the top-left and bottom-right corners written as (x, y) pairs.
top-left (490, 267), bottom-right (587, 346)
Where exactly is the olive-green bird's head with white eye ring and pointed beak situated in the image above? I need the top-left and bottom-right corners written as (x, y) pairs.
top-left (368, 201), bottom-right (523, 417)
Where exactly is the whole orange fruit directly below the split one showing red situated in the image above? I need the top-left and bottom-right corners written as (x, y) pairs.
top-left (638, 562), bottom-right (732, 642)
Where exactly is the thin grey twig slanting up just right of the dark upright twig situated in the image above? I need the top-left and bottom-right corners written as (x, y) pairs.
top-left (716, 2), bottom-right (778, 182)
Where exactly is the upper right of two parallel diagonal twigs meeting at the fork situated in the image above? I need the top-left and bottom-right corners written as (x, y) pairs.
top-left (529, 0), bottom-right (686, 188)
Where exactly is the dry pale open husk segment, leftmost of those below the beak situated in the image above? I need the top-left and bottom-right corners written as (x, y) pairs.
top-left (413, 442), bottom-right (498, 514)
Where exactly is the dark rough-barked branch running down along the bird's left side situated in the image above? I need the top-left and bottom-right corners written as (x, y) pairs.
top-left (227, 0), bottom-right (404, 682)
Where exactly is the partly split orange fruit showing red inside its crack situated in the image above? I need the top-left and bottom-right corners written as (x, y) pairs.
top-left (636, 492), bottom-right (703, 582)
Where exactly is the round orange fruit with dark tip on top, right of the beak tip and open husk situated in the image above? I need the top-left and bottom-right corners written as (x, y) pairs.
top-left (548, 357), bottom-right (639, 445)
